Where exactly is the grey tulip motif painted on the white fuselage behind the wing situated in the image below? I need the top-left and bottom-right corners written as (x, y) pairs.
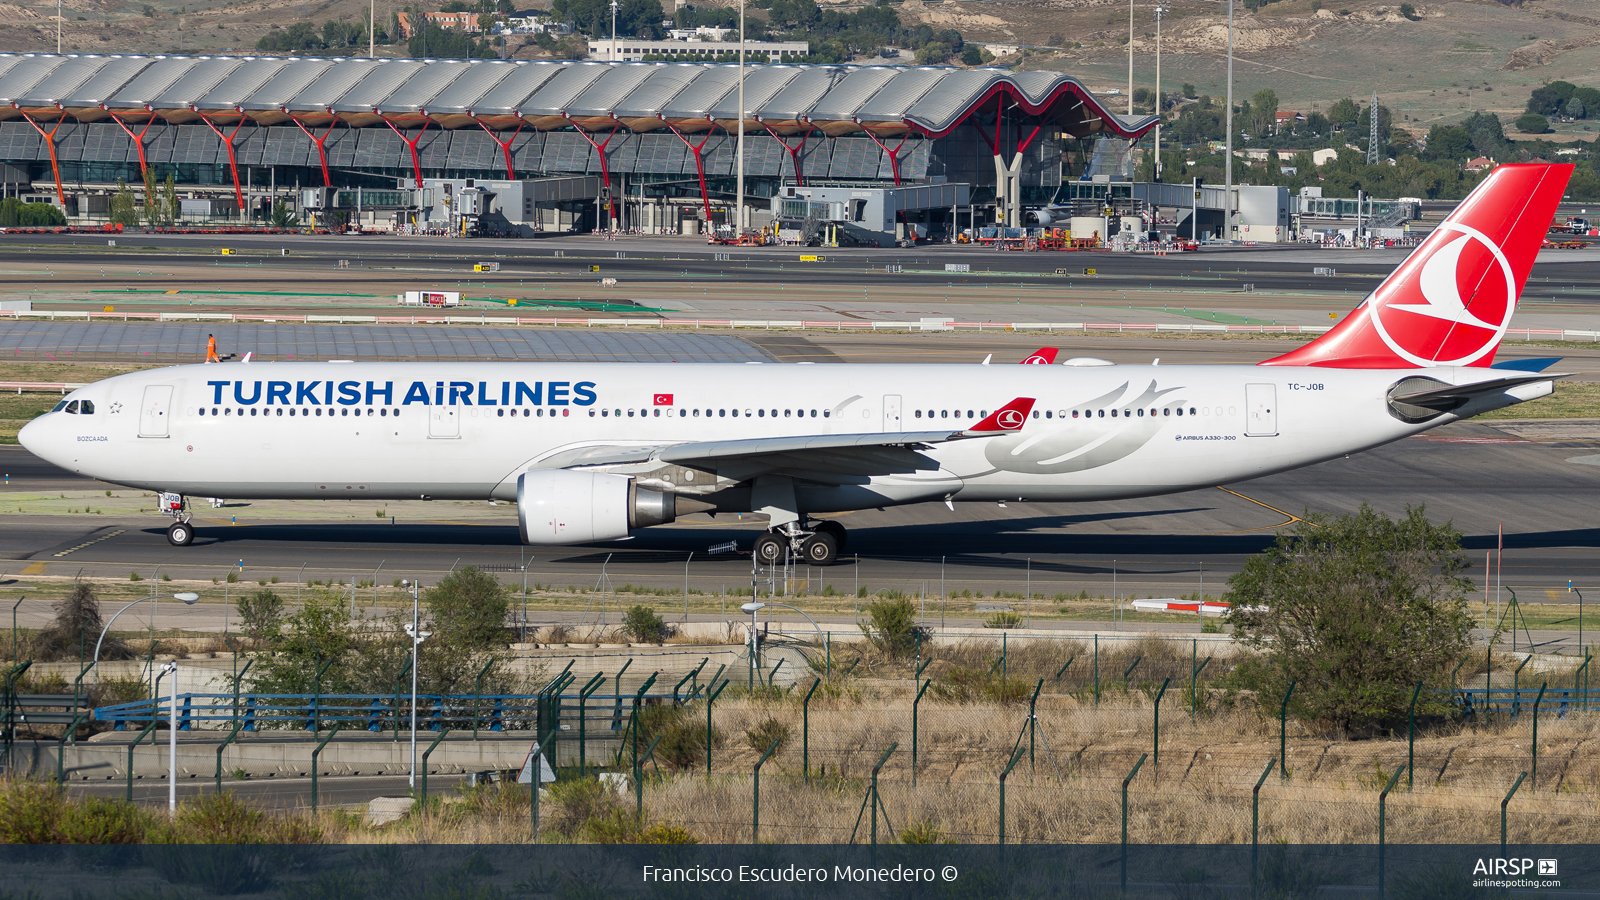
top-left (984, 381), bottom-right (1182, 476)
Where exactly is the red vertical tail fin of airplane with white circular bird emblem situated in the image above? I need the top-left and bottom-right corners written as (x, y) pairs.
top-left (1261, 163), bottom-right (1573, 368)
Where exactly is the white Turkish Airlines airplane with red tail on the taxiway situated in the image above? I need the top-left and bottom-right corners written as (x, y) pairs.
top-left (21, 165), bottom-right (1573, 565)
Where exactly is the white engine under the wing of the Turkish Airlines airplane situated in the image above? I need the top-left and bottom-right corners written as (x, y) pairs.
top-left (517, 469), bottom-right (675, 544)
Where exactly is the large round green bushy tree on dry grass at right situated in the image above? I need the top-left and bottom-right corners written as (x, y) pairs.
top-left (1227, 504), bottom-right (1474, 732)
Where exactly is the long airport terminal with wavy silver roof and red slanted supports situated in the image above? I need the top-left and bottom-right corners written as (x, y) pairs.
top-left (0, 54), bottom-right (1155, 240)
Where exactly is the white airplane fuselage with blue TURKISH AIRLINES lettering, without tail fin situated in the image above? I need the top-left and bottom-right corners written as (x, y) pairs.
top-left (21, 362), bottom-right (1529, 512)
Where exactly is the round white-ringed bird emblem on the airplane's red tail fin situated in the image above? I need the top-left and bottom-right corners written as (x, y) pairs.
top-left (1373, 223), bottom-right (1517, 365)
